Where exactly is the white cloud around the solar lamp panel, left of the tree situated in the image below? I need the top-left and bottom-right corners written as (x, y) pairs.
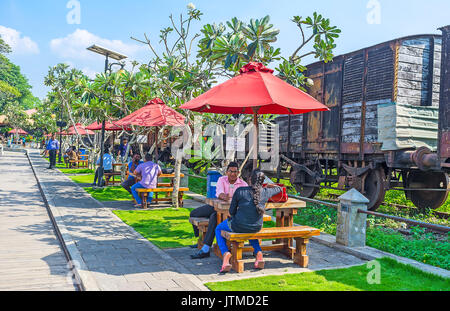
top-left (50, 29), bottom-right (145, 60)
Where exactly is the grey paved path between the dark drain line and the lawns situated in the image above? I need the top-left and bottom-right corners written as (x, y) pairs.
top-left (29, 150), bottom-right (206, 291)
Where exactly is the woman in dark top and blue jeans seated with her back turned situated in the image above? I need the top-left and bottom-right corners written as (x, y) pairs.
top-left (216, 169), bottom-right (282, 273)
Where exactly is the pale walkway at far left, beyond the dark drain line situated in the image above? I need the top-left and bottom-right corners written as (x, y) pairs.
top-left (0, 152), bottom-right (76, 291)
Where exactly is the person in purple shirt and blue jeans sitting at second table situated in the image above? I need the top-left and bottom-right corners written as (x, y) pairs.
top-left (131, 153), bottom-right (162, 208)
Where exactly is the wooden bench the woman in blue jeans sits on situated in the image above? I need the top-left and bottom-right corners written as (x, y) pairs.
top-left (222, 226), bottom-right (320, 273)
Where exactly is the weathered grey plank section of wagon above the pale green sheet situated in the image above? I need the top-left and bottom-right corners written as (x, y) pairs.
top-left (397, 38), bottom-right (442, 107)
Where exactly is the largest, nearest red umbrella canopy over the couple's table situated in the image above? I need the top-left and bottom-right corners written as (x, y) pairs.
top-left (180, 62), bottom-right (329, 114)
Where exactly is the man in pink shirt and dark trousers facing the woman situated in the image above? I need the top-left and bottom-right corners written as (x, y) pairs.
top-left (190, 162), bottom-right (248, 259)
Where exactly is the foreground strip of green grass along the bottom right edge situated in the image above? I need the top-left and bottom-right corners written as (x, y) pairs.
top-left (205, 258), bottom-right (450, 291)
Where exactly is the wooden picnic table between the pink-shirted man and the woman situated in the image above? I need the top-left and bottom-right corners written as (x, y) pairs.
top-left (205, 198), bottom-right (306, 259)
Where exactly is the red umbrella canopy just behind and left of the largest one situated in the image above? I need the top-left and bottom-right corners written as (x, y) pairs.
top-left (114, 98), bottom-right (185, 126)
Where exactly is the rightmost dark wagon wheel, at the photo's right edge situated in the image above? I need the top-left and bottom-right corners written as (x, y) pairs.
top-left (405, 171), bottom-right (449, 210)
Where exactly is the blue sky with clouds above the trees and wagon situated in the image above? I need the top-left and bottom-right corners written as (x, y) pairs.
top-left (0, 0), bottom-right (450, 98)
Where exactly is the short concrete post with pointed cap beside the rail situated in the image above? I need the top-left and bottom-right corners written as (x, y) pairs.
top-left (336, 189), bottom-right (369, 247)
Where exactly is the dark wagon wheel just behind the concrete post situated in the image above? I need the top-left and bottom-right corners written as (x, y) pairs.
top-left (363, 169), bottom-right (386, 211)
